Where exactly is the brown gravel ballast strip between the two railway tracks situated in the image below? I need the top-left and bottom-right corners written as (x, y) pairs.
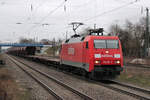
top-left (15, 55), bottom-right (135, 100)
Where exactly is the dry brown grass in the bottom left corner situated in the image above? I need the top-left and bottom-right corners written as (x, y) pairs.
top-left (0, 55), bottom-right (31, 100)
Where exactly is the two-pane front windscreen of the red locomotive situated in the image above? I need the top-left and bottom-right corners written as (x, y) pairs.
top-left (94, 40), bottom-right (119, 49)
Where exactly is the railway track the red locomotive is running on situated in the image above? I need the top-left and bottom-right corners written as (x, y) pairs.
top-left (8, 55), bottom-right (150, 100)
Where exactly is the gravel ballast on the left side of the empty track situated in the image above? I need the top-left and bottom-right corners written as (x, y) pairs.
top-left (6, 55), bottom-right (55, 100)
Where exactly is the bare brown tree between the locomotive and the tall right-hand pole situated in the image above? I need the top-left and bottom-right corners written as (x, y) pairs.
top-left (110, 20), bottom-right (144, 57)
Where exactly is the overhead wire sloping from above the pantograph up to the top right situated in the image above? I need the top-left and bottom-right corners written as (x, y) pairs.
top-left (85, 0), bottom-right (137, 21)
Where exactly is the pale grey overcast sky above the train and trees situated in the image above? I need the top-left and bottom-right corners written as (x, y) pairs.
top-left (0, 0), bottom-right (150, 42)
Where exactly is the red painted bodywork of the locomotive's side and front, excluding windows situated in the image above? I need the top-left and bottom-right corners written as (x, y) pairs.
top-left (60, 36), bottom-right (123, 72)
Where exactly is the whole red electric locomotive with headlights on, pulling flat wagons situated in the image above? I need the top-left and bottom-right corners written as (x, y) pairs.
top-left (60, 29), bottom-right (123, 79)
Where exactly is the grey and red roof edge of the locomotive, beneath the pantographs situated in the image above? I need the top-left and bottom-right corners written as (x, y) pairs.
top-left (65, 35), bottom-right (119, 43)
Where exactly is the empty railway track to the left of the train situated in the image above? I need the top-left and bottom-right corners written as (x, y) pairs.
top-left (8, 56), bottom-right (94, 100)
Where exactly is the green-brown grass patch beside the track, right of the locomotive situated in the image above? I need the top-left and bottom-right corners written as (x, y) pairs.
top-left (117, 72), bottom-right (150, 89)
